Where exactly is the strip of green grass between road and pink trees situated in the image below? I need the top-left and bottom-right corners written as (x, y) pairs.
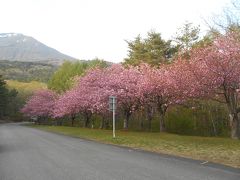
top-left (33, 125), bottom-right (240, 168)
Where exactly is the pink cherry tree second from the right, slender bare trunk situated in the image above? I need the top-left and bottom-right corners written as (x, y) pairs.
top-left (139, 64), bottom-right (182, 132)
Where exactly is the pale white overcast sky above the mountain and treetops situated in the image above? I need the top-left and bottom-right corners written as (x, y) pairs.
top-left (0, 0), bottom-right (231, 62)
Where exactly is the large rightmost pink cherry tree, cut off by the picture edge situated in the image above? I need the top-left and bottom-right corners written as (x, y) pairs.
top-left (189, 33), bottom-right (240, 139)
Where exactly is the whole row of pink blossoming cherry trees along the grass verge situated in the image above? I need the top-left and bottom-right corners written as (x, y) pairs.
top-left (22, 31), bottom-right (240, 138)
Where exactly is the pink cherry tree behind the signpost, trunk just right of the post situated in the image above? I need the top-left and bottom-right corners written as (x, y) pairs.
top-left (72, 64), bottom-right (141, 129)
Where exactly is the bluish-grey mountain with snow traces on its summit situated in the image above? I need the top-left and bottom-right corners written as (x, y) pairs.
top-left (0, 33), bottom-right (76, 64)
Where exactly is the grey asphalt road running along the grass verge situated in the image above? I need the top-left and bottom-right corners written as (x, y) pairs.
top-left (0, 124), bottom-right (240, 180)
